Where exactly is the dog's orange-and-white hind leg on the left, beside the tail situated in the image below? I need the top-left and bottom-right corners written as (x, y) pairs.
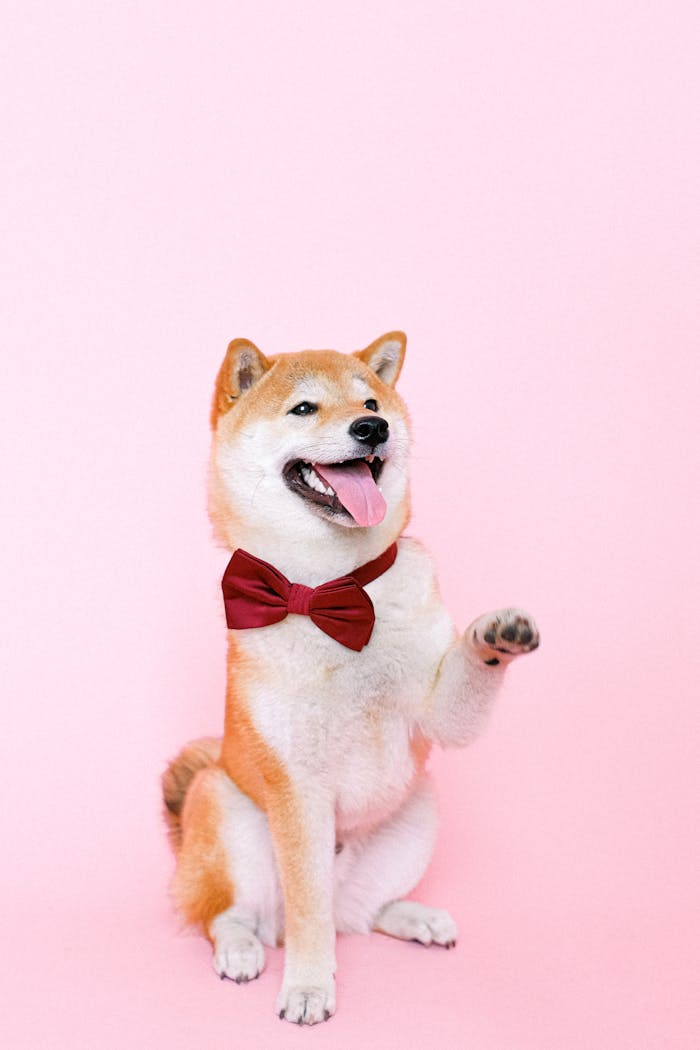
top-left (172, 765), bottom-right (281, 983)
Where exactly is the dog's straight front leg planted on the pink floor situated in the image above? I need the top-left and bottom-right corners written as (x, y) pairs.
top-left (268, 777), bottom-right (336, 1025)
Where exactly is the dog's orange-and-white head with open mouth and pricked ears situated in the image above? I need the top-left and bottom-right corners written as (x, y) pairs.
top-left (210, 332), bottom-right (409, 567)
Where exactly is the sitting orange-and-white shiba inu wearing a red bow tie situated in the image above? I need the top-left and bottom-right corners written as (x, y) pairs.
top-left (163, 332), bottom-right (538, 1025)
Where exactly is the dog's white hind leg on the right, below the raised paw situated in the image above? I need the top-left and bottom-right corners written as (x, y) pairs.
top-left (335, 778), bottom-right (457, 947)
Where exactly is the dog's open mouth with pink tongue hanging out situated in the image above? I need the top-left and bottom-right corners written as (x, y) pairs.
top-left (282, 455), bottom-right (386, 526)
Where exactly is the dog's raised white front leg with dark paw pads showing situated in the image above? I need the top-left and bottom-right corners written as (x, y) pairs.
top-left (420, 609), bottom-right (539, 747)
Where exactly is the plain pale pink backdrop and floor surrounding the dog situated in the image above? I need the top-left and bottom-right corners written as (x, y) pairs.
top-left (0, 0), bottom-right (700, 1050)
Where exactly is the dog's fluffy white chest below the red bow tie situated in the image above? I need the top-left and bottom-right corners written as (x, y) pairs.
top-left (234, 551), bottom-right (453, 827)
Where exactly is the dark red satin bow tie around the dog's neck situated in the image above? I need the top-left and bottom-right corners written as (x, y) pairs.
top-left (221, 543), bottom-right (397, 652)
